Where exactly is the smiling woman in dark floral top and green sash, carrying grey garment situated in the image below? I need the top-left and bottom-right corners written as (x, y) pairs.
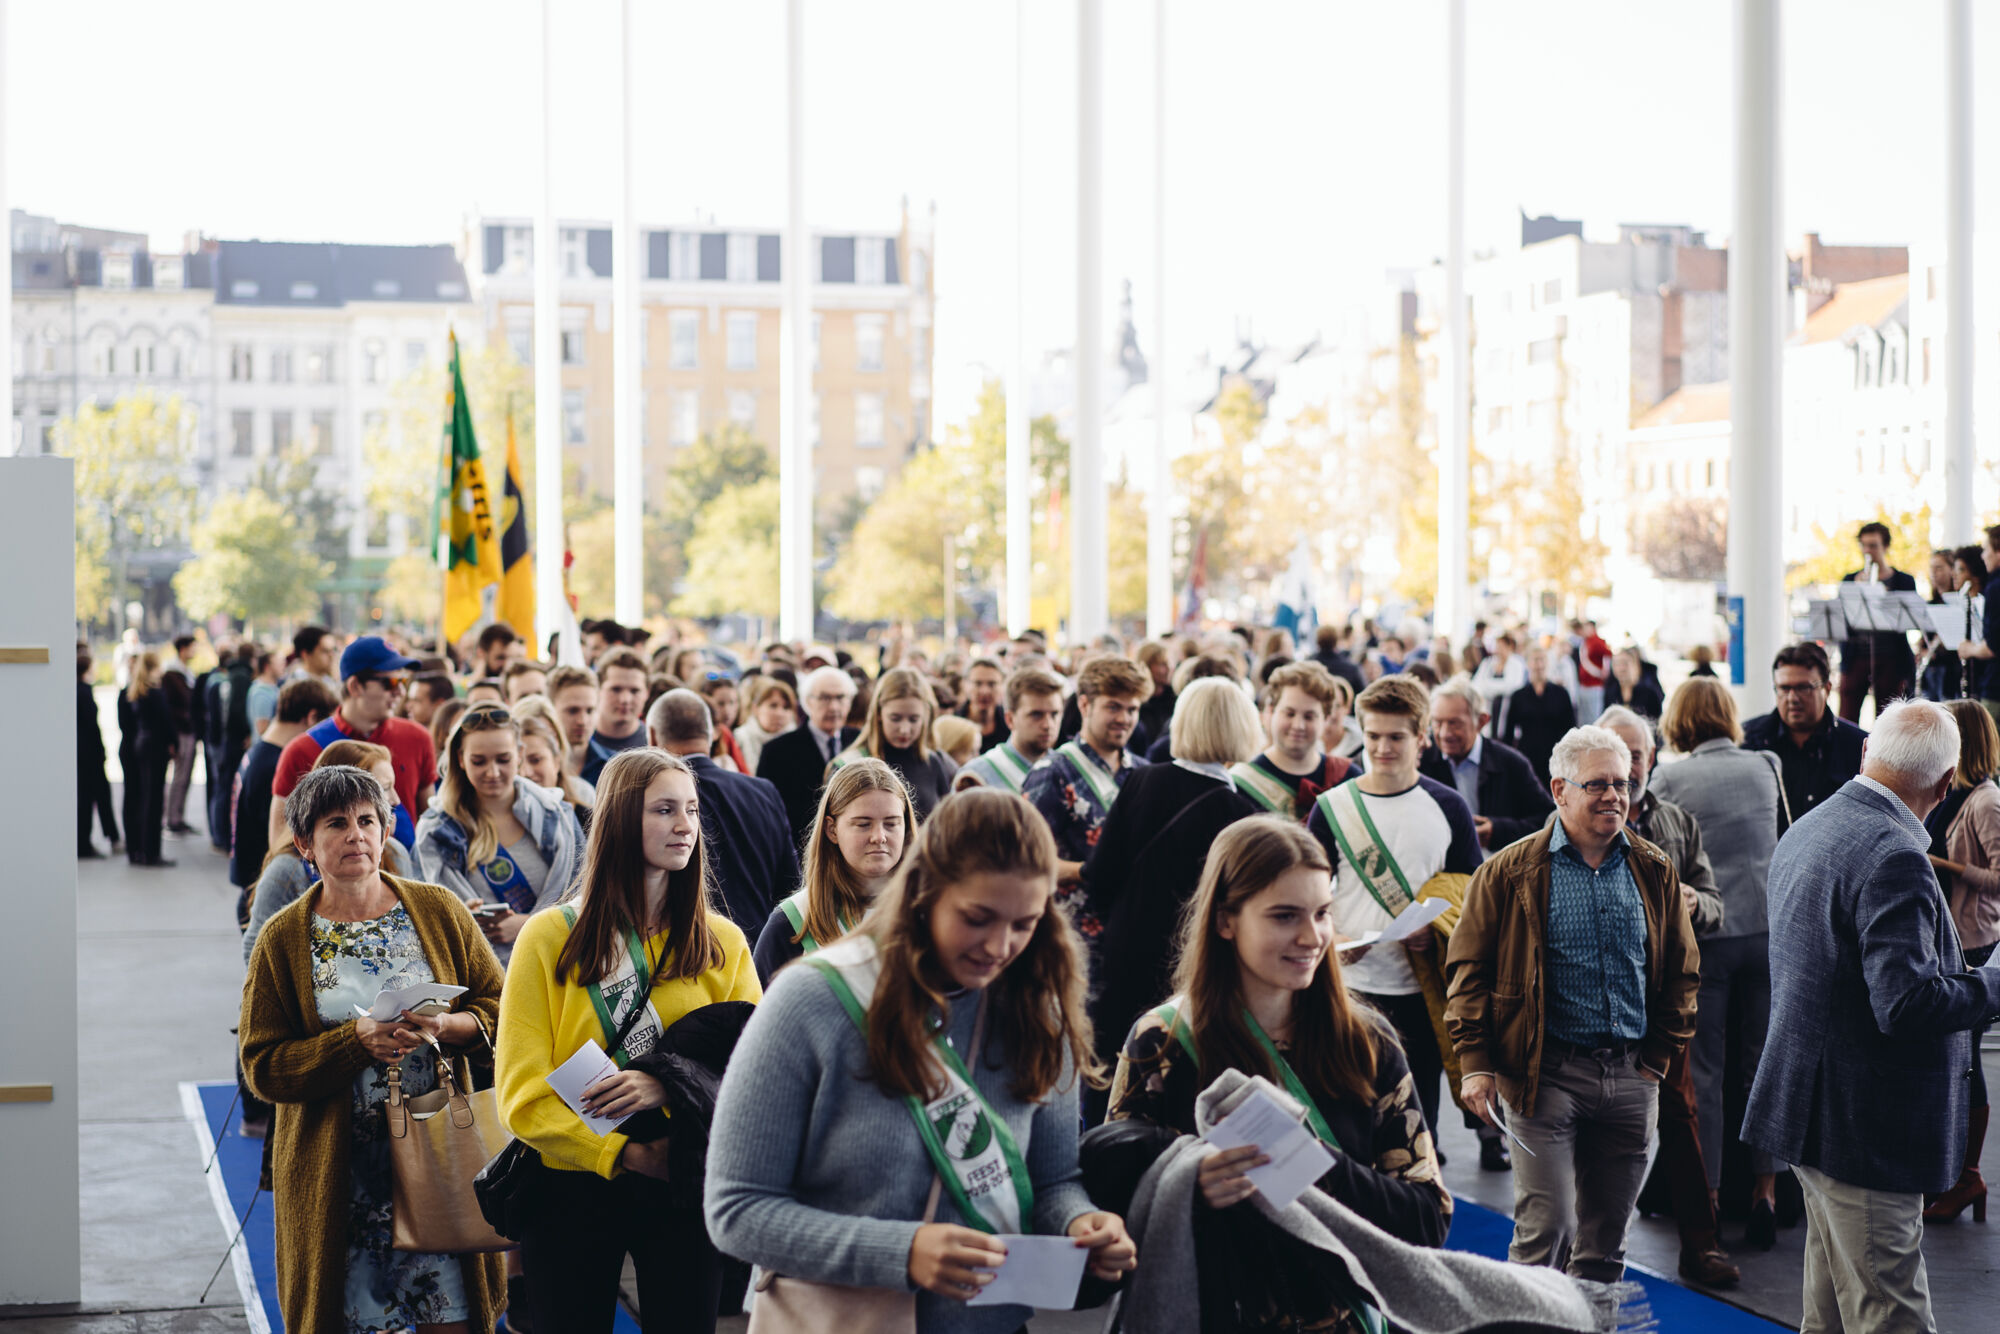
top-left (1110, 816), bottom-right (1452, 1330)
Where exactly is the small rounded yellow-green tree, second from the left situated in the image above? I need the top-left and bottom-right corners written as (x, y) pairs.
top-left (174, 490), bottom-right (332, 622)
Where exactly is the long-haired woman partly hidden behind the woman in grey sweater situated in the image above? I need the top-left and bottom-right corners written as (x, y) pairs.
top-left (750, 760), bottom-right (916, 986)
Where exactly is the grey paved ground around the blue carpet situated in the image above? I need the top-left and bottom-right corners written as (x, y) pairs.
top-left (0, 772), bottom-right (2000, 1334)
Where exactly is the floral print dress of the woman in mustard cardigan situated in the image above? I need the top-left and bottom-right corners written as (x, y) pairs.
top-left (312, 904), bottom-right (470, 1334)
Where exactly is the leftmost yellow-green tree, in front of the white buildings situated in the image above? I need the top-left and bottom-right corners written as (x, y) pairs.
top-left (54, 390), bottom-right (196, 622)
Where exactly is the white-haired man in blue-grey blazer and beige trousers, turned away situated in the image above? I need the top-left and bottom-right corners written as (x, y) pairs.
top-left (1742, 700), bottom-right (2000, 1334)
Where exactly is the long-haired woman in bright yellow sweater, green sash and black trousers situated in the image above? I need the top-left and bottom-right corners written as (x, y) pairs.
top-left (494, 748), bottom-right (762, 1334)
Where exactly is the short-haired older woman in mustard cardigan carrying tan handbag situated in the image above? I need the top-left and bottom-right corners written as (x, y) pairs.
top-left (240, 766), bottom-right (506, 1334)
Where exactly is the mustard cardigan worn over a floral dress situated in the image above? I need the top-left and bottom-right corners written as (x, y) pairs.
top-left (238, 874), bottom-right (506, 1334)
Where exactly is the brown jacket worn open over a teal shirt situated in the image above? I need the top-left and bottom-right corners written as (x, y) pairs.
top-left (1444, 816), bottom-right (1702, 1116)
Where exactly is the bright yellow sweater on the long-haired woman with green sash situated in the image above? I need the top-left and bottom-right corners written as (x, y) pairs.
top-left (494, 908), bottom-right (764, 1176)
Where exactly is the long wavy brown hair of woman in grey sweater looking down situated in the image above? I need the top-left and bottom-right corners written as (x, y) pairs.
top-left (858, 788), bottom-right (1104, 1102)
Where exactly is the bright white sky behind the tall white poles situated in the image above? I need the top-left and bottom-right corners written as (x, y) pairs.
top-left (6, 0), bottom-right (2000, 422)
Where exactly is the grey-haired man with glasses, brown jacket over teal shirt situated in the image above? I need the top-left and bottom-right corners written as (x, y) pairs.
top-left (1444, 726), bottom-right (1700, 1282)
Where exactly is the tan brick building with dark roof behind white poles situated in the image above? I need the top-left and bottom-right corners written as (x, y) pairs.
top-left (472, 210), bottom-right (936, 500)
